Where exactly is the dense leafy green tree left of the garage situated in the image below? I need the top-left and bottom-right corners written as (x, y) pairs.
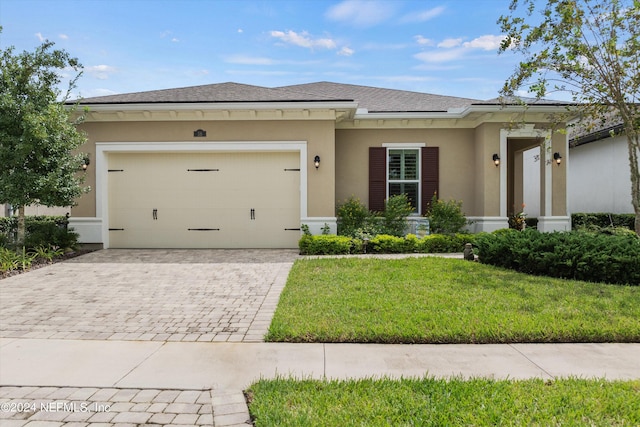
top-left (0, 27), bottom-right (86, 243)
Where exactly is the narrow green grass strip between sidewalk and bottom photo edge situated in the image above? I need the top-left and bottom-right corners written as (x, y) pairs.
top-left (247, 378), bottom-right (640, 427)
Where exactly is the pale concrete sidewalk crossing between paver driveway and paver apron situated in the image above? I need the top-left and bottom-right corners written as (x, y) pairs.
top-left (0, 338), bottom-right (640, 389)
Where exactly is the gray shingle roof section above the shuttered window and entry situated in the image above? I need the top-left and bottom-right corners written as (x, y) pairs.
top-left (277, 82), bottom-right (483, 113)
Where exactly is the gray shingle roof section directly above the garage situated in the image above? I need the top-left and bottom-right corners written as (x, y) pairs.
top-left (77, 82), bottom-right (352, 104)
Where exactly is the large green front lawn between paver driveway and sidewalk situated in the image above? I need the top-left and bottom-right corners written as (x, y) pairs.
top-left (266, 257), bottom-right (640, 343)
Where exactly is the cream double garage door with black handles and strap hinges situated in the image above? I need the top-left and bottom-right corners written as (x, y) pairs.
top-left (108, 152), bottom-right (300, 248)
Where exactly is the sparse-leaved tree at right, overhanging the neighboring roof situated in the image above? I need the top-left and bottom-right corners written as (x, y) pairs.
top-left (498, 0), bottom-right (640, 235)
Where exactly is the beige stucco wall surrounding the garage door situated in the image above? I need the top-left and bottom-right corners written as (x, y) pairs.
top-left (71, 120), bottom-right (335, 217)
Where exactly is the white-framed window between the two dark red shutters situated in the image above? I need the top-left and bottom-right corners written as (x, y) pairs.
top-left (387, 149), bottom-right (420, 213)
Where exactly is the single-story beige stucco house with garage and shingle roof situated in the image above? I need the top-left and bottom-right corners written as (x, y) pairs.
top-left (71, 82), bottom-right (570, 248)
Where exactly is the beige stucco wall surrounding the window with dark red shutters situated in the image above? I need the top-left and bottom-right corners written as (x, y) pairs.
top-left (336, 129), bottom-right (477, 215)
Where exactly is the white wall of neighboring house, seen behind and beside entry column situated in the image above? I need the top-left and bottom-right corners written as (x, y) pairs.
top-left (524, 136), bottom-right (633, 216)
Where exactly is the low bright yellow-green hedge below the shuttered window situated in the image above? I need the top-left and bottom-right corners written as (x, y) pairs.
top-left (298, 234), bottom-right (475, 255)
